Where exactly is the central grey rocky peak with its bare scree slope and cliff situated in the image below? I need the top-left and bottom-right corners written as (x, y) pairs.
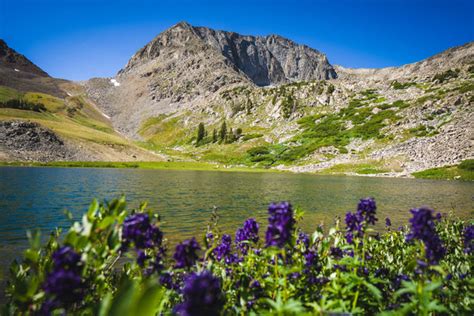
top-left (86, 22), bottom-right (337, 138)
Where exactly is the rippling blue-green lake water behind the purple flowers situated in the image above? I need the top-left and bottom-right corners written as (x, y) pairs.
top-left (0, 167), bottom-right (474, 266)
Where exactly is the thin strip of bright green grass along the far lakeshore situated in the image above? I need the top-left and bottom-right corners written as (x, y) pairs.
top-left (0, 161), bottom-right (283, 172)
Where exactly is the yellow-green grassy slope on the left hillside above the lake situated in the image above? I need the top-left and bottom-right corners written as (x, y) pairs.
top-left (0, 86), bottom-right (158, 160)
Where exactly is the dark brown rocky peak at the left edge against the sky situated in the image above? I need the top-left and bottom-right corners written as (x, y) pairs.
top-left (0, 39), bottom-right (49, 77)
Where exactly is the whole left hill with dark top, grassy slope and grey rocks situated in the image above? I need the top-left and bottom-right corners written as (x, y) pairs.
top-left (0, 40), bottom-right (160, 161)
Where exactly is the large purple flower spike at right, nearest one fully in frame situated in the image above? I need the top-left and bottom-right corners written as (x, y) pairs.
top-left (406, 207), bottom-right (446, 264)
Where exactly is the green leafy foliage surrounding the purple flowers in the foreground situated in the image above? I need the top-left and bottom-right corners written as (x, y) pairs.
top-left (4, 198), bottom-right (474, 316)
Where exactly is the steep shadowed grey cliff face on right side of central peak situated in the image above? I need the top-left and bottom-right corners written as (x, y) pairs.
top-left (193, 27), bottom-right (337, 86)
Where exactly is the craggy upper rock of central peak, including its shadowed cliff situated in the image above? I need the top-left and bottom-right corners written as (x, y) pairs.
top-left (123, 21), bottom-right (337, 86)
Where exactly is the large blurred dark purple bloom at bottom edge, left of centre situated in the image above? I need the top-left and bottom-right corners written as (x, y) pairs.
top-left (175, 271), bottom-right (224, 316)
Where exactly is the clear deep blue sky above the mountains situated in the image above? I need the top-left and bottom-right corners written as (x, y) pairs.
top-left (0, 0), bottom-right (474, 80)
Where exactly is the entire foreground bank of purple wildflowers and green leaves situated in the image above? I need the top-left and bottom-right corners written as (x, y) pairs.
top-left (6, 198), bottom-right (474, 315)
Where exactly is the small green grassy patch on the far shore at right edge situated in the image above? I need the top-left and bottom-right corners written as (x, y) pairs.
top-left (413, 159), bottom-right (474, 181)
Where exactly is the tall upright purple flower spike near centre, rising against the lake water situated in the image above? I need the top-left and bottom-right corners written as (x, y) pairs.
top-left (265, 202), bottom-right (295, 248)
